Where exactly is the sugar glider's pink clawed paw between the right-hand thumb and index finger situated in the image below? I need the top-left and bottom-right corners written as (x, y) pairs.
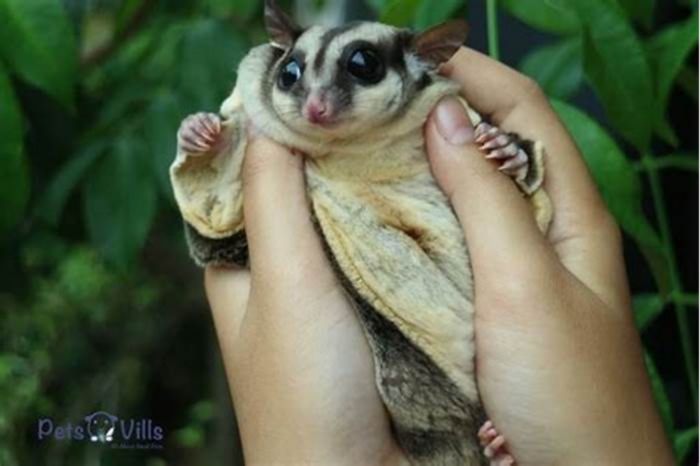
top-left (474, 121), bottom-right (530, 180)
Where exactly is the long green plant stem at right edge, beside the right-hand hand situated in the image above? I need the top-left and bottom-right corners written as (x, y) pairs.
top-left (642, 154), bottom-right (698, 419)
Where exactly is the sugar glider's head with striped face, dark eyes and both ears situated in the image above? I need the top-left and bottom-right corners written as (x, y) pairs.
top-left (258, 0), bottom-right (467, 138)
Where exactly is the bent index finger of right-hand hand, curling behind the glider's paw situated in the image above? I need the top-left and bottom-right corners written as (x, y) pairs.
top-left (443, 48), bottom-right (629, 309)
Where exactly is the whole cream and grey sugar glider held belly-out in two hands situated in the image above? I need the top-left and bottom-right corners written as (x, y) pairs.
top-left (170, 1), bottom-right (551, 465)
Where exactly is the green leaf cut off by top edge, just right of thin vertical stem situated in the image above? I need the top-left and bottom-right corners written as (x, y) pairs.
top-left (499, 0), bottom-right (580, 34)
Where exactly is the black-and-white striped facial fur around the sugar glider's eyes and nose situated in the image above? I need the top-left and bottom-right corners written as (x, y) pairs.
top-left (271, 23), bottom-right (430, 138)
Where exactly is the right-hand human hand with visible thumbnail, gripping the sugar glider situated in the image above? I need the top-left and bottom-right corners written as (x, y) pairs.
top-left (425, 49), bottom-right (673, 466)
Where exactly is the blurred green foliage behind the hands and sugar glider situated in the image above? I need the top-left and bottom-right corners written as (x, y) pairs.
top-left (0, 0), bottom-right (698, 466)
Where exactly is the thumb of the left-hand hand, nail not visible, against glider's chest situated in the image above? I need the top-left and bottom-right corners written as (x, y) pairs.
top-left (243, 132), bottom-right (335, 289)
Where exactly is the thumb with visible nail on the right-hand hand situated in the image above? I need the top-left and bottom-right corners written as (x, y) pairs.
top-left (426, 98), bottom-right (551, 283)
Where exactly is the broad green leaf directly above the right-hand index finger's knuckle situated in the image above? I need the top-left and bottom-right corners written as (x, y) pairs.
top-left (520, 38), bottom-right (583, 100)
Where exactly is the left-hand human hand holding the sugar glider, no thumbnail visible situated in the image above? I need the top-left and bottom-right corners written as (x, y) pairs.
top-left (206, 133), bottom-right (403, 465)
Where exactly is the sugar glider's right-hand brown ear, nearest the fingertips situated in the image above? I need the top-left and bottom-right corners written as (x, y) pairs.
top-left (410, 19), bottom-right (469, 68)
